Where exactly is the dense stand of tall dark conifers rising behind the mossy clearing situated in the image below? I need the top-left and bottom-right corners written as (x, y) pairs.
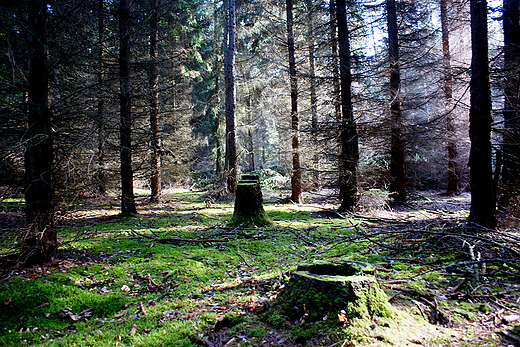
top-left (0, 0), bottom-right (520, 262)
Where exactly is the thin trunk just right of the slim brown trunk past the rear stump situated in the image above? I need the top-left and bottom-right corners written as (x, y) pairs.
top-left (307, 0), bottom-right (320, 188)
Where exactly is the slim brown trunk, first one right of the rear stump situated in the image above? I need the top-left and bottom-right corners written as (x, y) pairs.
top-left (286, 0), bottom-right (303, 204)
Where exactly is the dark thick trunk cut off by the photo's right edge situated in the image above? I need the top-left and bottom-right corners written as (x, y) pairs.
top-left (500, 0), bottom-right (520, 212)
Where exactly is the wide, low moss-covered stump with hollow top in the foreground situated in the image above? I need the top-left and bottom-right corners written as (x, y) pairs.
top-left (273, 261), bottom-right (393, 322)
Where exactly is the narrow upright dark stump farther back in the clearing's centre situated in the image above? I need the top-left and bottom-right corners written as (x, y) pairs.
top-left (228, 175), bottom-right (273, 227)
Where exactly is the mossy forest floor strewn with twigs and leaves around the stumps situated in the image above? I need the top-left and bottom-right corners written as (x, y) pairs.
top-left (0, 190), bottom-right (520, 347)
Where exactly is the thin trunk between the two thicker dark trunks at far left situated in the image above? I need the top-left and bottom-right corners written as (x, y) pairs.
top-left (96, 0), bottom-right (107, 196)
